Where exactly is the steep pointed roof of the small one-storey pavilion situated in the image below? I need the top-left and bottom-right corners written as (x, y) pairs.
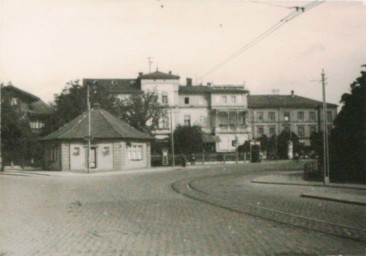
top-left (41, 107), bottom-right (153, 140)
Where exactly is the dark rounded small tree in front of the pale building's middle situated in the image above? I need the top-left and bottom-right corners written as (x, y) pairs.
top-left (174, 125), bottom-right (203, 154)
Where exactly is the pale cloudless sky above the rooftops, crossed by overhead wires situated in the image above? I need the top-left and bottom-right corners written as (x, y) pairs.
top-left (0, 0), bottom-right (366, 104)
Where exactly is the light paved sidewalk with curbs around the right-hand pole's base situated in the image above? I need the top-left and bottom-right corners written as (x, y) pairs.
top-left (252, 171), bottom-right (366, 205)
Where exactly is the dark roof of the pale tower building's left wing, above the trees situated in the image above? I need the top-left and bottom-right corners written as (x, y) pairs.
top-left (83, 78), bottom-right (140, 94)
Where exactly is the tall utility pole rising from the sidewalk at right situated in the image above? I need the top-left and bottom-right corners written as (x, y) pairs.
top-left (322, 69), bottom-right (329, 185)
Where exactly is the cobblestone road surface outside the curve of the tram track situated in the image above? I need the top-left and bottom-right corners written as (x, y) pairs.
top-left (0, 165), bottom-right (366, 256)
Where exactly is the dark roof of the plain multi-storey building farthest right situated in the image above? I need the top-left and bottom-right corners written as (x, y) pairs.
top-left (248, 95), bottom-right (337, 108)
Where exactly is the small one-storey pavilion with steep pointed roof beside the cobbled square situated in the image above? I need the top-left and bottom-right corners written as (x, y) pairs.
top-left (41, 105), bottom-right (153, 171)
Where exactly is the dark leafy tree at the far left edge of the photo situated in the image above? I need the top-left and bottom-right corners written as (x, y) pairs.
top-left (1, 85), bottom-right (37, 167)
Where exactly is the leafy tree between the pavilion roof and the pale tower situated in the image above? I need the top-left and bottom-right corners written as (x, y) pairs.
top-left (113, 92), bottom-right (166, 132)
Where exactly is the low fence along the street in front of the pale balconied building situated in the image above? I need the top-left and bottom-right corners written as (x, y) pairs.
top-left (151, 152), bottom-right (250, 166)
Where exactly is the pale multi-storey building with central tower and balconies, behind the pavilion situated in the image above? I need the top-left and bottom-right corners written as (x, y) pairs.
top-left (83, 71), bottom-right (251, 152)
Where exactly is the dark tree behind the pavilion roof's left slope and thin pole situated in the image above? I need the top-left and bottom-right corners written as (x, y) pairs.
top-left (45, 80), bottom-right (116, 133)
